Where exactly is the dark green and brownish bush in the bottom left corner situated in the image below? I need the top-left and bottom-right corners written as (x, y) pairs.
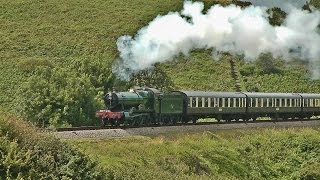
top-left (0, 111), bottom-right (106, 179)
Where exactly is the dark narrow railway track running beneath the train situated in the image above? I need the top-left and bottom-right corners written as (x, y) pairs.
top-left (56, 119), bottom-right (320, 132)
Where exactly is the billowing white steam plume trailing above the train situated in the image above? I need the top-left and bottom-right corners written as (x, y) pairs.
top-left (113, 1), bottom-right (320, 79)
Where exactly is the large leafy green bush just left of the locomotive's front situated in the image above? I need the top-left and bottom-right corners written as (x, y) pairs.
top-left (15, 64), bottom-right (102, 127)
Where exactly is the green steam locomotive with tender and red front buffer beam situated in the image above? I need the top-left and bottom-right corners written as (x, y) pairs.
top-left (96, 88), bottom-right (184, 126)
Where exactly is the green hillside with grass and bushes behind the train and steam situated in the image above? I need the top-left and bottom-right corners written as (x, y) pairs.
top-left (0, 0), bottom-right (320, 127)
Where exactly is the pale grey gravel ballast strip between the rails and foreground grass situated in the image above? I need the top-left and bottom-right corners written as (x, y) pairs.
top-left (55, 120), bottom-right (320, 139)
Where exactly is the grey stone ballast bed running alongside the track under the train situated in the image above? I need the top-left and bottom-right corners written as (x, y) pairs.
top-left (55, 119), bottom-right (320, 139)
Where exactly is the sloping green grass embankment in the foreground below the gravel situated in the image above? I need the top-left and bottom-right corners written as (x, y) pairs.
top-left (70, 128), bottom-right (320, 179)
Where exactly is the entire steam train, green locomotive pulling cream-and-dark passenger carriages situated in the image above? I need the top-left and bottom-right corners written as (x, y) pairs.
top-left (96, 88), bottom-right (320, 126)
